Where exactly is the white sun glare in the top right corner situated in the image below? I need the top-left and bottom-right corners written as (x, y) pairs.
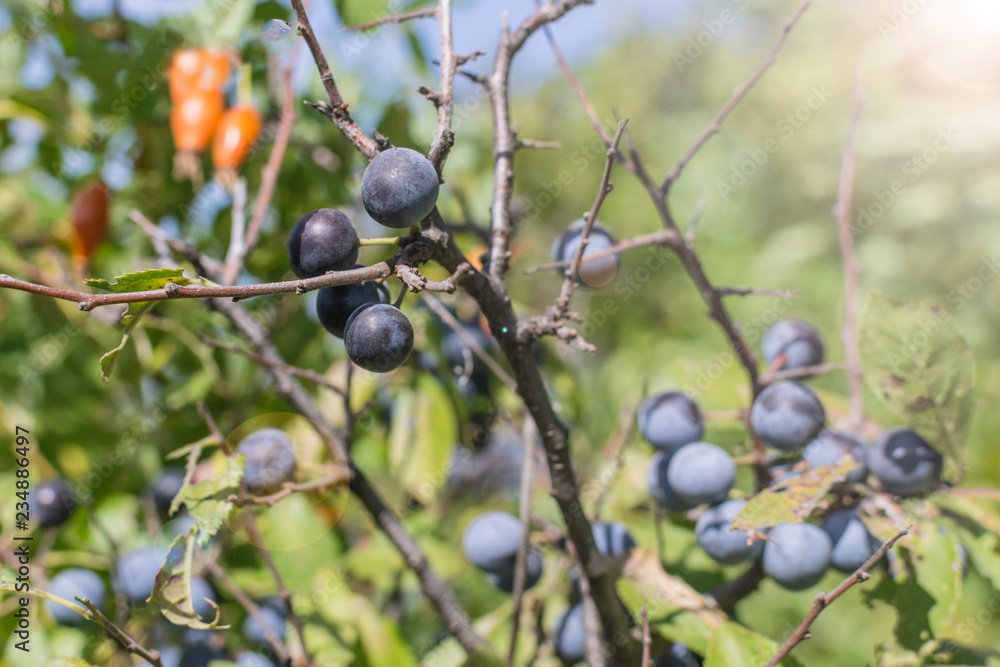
top-left (891, 0), bottom-right (1000, 90)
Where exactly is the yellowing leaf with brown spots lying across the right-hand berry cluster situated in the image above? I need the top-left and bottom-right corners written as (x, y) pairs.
top-left (732, 456), bottom-right (858, 533)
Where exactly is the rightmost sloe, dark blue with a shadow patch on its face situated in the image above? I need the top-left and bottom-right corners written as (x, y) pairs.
top-left (868, 427), bottom-right (944, 497)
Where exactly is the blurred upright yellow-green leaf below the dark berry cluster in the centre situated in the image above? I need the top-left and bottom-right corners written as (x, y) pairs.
top-left (389, 374), bottom-right (458, 502)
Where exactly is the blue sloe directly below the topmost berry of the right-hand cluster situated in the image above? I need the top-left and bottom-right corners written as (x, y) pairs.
top-left (750, 382), bottom-right (826, 452)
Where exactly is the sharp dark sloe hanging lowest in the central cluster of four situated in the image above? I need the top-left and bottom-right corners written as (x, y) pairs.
top-left (344, 303), bottom-right (413, 373)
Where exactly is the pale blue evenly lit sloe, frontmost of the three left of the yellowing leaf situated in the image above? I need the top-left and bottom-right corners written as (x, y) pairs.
top-left (667, 442), bottom-right (736, 506)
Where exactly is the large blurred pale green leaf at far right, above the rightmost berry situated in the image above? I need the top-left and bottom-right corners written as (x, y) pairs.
top-left (859, 290), bottom-right (973, 470)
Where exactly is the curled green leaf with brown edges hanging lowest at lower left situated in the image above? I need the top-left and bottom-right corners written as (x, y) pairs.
top-left (148, 528), bottom-right (229, 630)
